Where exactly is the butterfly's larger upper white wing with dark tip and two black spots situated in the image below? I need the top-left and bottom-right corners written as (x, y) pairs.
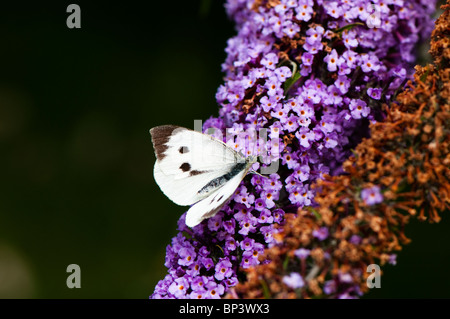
top-left (150, 125), bottom-right (245, 209)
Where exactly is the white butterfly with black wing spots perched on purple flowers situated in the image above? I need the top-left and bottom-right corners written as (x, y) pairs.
top-left (150, 125), bottom-right (257, 227)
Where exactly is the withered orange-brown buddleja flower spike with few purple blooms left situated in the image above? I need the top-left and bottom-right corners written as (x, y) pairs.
top-left (228, 0), bottom-right (450, 298)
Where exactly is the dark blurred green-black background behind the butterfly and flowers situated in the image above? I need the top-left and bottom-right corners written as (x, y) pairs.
top-left (0, 0), bottom-right (450, 298)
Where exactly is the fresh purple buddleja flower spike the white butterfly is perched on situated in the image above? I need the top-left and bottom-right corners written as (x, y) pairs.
top-left (152, 0), bottom-right (434, 298)
